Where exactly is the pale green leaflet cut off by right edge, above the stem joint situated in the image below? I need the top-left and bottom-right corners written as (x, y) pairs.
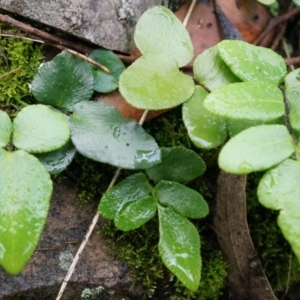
top-left (284, 69), bottom-right (300, 131)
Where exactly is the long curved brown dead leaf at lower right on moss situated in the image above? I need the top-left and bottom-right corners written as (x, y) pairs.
top-left (214, 171), bottom-right (277, 300)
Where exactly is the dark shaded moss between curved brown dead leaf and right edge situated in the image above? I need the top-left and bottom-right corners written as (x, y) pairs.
top-left (246, 173), bottom-right (300, 298)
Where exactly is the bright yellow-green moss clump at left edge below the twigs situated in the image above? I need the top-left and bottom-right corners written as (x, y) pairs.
top-left (0, 30), bottom-right (43, 114)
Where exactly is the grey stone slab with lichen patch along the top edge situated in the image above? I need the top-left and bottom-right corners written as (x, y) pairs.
top-left (0, 0), bottom-right (182, 53)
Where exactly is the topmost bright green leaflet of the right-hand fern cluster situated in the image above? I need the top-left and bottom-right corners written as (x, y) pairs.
top-left (218, 40), bottom-right (287, 84)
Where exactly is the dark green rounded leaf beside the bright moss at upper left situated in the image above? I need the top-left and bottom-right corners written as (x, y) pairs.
top-left (31, 51), bottom-right (94, 111)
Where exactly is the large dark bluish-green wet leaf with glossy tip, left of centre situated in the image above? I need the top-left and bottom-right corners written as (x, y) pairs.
top-left (69, 101), bottom-right (160, 169)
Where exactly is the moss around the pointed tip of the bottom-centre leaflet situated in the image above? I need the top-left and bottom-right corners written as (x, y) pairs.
top-left (101, 218), bottom-right (227, 300)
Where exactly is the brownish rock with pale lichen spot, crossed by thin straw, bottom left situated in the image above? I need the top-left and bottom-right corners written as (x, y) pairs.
top-left (0, 182), bottom-right (137, 300)
